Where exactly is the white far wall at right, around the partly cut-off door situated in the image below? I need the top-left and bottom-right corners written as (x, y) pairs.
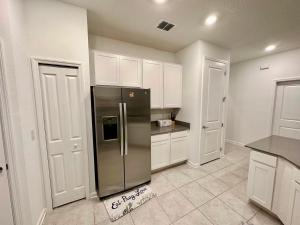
top-left (226, 49), bottom-right (300, 144)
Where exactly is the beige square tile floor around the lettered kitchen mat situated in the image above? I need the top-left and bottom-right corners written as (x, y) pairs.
top-left (44, 144), bottom-right (281, 225)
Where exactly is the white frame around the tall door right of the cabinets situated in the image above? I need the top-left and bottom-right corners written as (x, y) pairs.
top-left (199, 56), bottom-right (230, 162)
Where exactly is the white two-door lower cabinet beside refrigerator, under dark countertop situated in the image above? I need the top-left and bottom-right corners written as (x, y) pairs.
top-left (151, 131), bottom-right (188, 170)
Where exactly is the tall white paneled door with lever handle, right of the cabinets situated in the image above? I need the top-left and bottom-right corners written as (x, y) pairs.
top-left (200, 59), bottom-right (226, 164)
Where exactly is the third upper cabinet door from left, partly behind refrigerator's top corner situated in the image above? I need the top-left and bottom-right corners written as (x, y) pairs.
top-left (143, 60), bottom-right (163, 109)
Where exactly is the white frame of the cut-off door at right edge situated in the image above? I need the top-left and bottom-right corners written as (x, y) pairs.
top-left (269, 76), bottom-right (300, 136)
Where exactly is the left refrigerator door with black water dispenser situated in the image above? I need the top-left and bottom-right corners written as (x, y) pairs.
top-left (92, 87), bottom-right (124, 197)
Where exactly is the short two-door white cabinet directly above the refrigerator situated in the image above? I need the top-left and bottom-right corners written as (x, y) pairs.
top-left (91, 51), bottom-right (142, 87)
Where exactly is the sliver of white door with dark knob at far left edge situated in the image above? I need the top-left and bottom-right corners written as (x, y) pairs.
top-left (0, 118), bottom-right (14, 225)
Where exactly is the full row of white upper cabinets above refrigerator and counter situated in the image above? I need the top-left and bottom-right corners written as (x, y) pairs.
top-left (90, 50), bottom-right (182, 109)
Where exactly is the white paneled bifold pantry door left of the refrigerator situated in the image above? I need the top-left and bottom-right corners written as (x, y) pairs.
top-left (39, 65), bottom-right (85, 207)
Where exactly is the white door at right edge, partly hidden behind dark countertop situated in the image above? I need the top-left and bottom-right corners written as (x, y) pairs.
top-left (273, 81), bottom-right (300, 139)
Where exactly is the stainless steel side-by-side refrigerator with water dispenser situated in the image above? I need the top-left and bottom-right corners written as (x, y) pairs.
top-left (91, 86), bottom-right (151, 198)
